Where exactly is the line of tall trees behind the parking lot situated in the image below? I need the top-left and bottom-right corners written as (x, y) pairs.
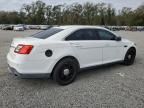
top-left (0, 0), bottom-right (144, 26)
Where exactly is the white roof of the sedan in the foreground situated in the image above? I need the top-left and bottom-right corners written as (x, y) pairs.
top-left (56, 25), bottom-right (105, 29)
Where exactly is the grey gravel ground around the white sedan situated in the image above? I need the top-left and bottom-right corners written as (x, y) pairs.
top-left (0, 31), bottom-right (144, 108)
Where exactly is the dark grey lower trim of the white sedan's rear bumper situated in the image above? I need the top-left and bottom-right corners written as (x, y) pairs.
top-left (8, 65), bottom-right (51, 78)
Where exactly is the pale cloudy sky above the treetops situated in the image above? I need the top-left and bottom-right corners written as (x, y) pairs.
top-left (0, 0), bottom-right (144, 11)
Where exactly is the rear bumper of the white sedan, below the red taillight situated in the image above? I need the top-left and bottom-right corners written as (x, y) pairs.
top-left (7, 53), bottom-right (54, 77)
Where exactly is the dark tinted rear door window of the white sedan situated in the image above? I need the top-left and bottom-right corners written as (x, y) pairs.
top-left (66, 29), bottom-right (99, 41)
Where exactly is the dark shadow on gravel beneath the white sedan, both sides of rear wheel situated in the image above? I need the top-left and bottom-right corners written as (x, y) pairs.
top-left (8, 62), bottom-right (136, 88)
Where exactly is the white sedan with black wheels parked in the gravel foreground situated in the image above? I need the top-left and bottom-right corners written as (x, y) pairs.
top-left (7, 26), bottom-right (136, 85)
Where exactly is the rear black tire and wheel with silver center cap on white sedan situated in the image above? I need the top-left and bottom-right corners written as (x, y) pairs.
top-left (53, 58), bottom-right (79, 85)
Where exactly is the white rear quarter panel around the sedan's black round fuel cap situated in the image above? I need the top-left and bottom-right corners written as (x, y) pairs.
top-left (30, 41), bottom-right (77, 73)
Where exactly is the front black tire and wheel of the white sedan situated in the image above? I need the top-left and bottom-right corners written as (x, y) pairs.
top-left (123, 48), bottom-right (136, 66)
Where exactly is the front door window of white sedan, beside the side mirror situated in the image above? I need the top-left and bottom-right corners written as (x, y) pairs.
top-left (97, 30), bottom-right (115, 40)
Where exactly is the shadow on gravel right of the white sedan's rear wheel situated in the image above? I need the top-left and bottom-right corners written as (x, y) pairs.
top-left (77, 57), bottom-right (140, 80)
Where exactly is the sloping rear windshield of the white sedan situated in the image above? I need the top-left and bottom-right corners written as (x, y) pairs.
top-left (32, 27), bottom-right (63, 39)
